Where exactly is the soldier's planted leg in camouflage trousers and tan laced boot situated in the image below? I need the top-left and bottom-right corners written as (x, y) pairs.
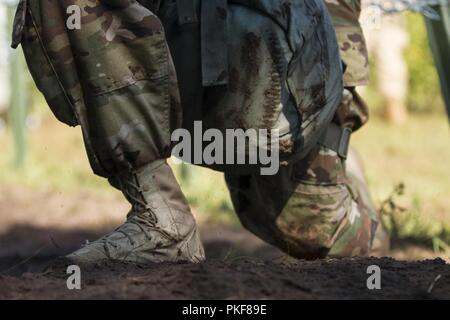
top-left (15, 0), bottom-right (204, 264)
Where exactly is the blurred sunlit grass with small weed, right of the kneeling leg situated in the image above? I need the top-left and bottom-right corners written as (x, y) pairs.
top-left (354, 113), bottom-right (450, 253)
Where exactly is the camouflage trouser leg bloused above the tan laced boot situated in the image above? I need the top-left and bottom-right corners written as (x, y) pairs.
top-left (15, 0), bottom-right (182, 177)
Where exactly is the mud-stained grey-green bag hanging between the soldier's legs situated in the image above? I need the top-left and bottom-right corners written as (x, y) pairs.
top-left (158, 0), bottom-right (342, 165)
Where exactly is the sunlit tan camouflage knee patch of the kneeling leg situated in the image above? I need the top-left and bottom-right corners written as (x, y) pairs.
top-left (275, 184), bottom-right (358, 259)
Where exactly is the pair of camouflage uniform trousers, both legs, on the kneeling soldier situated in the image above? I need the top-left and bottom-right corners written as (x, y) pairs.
top-left (14, 0), bottom-right (376, 258)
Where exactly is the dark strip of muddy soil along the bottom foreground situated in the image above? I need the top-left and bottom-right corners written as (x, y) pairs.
top-left (0, 258), bottom-right (450, 300)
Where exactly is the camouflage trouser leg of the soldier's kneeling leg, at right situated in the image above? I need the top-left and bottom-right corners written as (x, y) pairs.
top-left (226, 90), bottom-right (378, 259)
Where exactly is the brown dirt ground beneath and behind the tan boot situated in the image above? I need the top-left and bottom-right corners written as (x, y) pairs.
top-left (0, 187), bottom-right (450, 299)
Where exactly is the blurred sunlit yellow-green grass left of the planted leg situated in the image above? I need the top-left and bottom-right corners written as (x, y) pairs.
top-left (0, 114), bottom-right (109, 192)
